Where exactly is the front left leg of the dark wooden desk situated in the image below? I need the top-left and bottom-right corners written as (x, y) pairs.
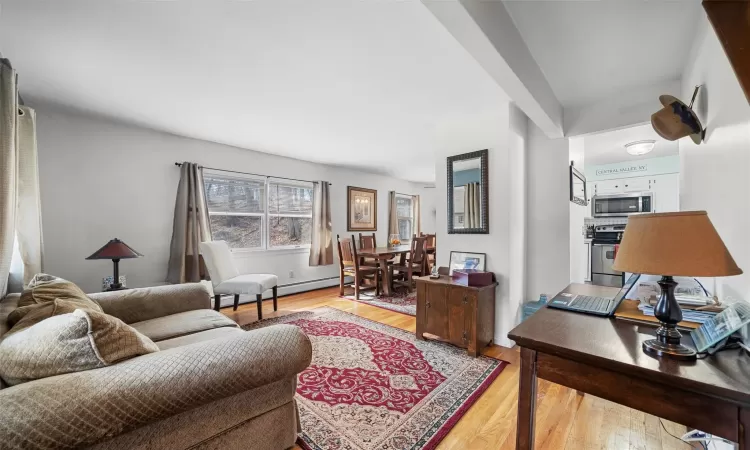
top-left (516, 347), bottom-right (537, 450)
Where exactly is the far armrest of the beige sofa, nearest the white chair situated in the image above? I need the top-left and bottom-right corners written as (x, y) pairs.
top-left (88, 283), bottom-right (211, 323)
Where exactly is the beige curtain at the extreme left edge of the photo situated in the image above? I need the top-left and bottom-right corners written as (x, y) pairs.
top-left (0, 59), bottom-right (18, 298)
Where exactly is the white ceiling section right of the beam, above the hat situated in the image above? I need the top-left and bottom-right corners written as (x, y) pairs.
top-left (504, 0), bottom-right (702, 107)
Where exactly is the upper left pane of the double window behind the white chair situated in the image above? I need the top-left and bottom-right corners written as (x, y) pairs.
top-left (204, 175), bottom-right (265, 213)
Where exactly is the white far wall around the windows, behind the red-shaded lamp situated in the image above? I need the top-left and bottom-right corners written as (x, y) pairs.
top-left (32, 104), bottom-right (427, 292)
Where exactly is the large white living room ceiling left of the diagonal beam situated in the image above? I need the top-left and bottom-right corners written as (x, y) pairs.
top-left (0, 0), bottom-right (512, 181)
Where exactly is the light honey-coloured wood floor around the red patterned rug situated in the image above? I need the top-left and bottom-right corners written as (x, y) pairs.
top-left (222, 288), bottom-right (691, 450)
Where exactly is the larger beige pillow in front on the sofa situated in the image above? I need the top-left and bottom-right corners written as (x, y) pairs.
top-left (0, 309), bottom-right (159, 386)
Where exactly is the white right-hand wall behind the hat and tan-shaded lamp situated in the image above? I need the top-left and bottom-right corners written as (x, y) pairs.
top-left (679, 15), bottom-right (750, 300)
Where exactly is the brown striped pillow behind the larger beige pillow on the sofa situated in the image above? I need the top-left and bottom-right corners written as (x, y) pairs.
top-left (8, 273), bottom-right (102, 333)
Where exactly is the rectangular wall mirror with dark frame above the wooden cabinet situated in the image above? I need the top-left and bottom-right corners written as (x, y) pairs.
top-left (447, 150), bottom-right (490, 234)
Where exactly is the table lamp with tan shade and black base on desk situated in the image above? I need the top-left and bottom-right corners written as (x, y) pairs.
top-left (613, 211), bottom-right (742, 360)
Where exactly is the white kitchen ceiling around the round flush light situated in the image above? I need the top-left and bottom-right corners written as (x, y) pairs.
top-left (579, 124), bottom-right (680, 167)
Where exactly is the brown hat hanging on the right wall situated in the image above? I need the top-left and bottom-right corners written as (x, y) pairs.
top-left (651, 87), bottom-right (704, 144)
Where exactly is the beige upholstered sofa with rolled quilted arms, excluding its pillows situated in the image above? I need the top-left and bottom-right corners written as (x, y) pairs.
top-left (0, 284), bottom-right (312, 449)
